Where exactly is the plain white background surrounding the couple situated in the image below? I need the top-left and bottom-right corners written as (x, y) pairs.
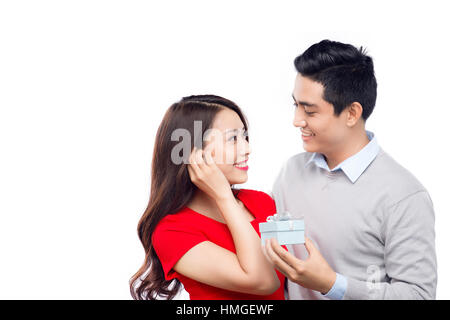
top-left (0, 0), bottom-right (450, 299)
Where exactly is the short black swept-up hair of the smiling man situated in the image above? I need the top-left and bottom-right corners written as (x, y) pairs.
top-left (294, 40), bottom-right (377, 120)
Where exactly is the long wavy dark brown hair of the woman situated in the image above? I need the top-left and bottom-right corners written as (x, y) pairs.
top-left (130, 95), bottom-right (248, 300)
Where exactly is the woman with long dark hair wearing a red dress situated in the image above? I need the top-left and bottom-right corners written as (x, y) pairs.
top-left (130, 95), bottom-right (284, 300)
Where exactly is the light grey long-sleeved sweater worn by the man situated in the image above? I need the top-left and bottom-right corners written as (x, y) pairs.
top-left (272, 149), bottom-right (437, 299)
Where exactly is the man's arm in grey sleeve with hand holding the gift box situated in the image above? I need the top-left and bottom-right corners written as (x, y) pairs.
top-left (266, 191), bottom-right (437, 300)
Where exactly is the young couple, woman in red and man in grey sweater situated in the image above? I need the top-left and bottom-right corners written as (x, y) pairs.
top-left (130, 40), bottom-right (437, 300)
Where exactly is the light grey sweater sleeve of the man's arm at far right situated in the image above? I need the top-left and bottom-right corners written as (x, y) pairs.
top-left (344, 190), bottom-right (437, 300)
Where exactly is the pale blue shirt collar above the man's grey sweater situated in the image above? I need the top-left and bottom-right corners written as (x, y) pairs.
top-left (305, 131), bottom-right (380, 183)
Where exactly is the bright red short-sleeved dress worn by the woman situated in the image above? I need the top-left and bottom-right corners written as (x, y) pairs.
top-left (152, 189), bottom-right (286, 300)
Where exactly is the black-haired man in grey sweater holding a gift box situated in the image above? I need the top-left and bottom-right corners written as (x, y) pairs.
top-left (265, 40), bottom-right (437, 299)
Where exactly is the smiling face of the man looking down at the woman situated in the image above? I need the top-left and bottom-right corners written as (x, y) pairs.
top-left (292, 73), bottom-right (347, 155)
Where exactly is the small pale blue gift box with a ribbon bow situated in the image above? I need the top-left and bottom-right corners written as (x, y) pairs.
top-left (259, 212), bottom-right (305, 245)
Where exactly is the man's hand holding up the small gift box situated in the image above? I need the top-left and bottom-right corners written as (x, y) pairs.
top-left (266, 237), bottom-right (336, 294)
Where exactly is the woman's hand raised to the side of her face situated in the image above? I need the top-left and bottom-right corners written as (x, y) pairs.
top-left (188, 147), bottom-right (234, 202)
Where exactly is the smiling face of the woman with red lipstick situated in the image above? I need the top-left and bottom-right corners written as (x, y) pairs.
top-left (204, 108), bottom-right (250, 185)
